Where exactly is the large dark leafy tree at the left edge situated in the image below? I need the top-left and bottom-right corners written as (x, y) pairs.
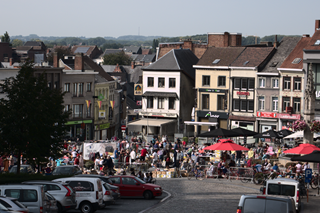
top-left (0, 62), bottom-right (69, 173)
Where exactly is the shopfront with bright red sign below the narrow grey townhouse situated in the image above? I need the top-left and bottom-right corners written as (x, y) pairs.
top-left (256, 111), bottom-right (278, 132)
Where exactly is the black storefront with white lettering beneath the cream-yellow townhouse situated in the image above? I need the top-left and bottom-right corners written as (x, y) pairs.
top-left (197, 111), bottom-right (229, 132)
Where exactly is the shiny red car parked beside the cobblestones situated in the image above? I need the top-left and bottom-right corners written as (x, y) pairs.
top-left (109, 175), bottom-right (162, 199)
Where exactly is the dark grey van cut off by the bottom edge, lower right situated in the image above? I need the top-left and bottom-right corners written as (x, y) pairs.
top-left (237, 195), bottom-right (296, 213)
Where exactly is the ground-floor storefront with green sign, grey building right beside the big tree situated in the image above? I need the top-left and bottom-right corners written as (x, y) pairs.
top-left (65, 120), bottom-right (93, 141)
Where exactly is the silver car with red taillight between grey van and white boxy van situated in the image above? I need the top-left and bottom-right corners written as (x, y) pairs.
top-left (22, 180), bottom-right (77, 212)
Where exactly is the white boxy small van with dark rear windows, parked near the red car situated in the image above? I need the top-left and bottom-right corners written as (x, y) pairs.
top-left (54, 177), bottom-right (104, 213)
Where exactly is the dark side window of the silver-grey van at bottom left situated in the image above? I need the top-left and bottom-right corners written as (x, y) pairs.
top-left (5, 189), bottom-right (38, 202)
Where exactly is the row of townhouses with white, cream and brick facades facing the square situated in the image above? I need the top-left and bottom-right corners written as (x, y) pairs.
top-left (129, 20), bottom-right (320, 140)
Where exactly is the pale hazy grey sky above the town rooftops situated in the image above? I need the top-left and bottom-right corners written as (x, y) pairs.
top-left (0, 0), bottom-right (320, 37)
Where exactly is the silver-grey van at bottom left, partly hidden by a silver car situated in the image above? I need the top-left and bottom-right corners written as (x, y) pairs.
top-left (0, 184), bottom-right (50, 213)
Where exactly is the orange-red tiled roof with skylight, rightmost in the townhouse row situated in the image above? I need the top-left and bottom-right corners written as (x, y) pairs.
top-left (280, 37), bottom-right (311, 69)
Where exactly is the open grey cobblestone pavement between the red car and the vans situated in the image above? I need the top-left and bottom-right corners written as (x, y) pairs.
top-left (147, 178), bottom-right (320, 213)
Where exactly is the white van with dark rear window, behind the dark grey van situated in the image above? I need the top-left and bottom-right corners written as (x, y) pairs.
top-left (260, 178), bottom-right (301, 211)
